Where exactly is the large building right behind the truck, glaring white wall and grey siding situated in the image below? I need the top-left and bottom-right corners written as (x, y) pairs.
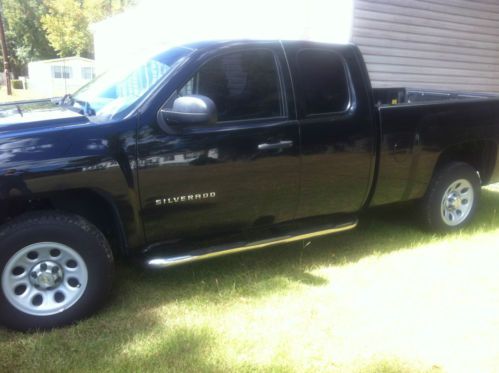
top-left (92, 0), bottom-right (499, 92)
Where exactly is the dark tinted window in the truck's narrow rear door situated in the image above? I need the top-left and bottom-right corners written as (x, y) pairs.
top-left (298, 49), bottom-right (350, 115)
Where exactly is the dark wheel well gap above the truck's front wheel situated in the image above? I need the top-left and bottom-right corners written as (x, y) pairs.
top-left (0, 189), bottom-right (127, 257)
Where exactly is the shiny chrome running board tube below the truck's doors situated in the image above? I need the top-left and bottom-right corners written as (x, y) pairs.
top-left (145, 221), bottom-right (357, 268)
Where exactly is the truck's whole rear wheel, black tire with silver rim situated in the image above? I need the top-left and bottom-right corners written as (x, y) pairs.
top-left (421, 162), bottom-right (481, 232)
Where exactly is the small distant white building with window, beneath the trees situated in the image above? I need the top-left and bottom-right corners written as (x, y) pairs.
top-left (28, 57), bottom-right (95, 97)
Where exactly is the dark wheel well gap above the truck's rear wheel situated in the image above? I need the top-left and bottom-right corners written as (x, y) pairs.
top-left (435, 141), bottom-right (497, 185)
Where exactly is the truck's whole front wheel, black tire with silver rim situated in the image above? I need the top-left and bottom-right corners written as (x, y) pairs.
top-left (0, 211), bottom-right (114, 331)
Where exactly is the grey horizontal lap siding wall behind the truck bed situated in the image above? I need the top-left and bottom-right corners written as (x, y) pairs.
top-left (352, 0), bottom-right (499, 92)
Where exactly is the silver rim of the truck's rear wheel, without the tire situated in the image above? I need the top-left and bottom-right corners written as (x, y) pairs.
top-left (440, 179), bottom-right (474, 226)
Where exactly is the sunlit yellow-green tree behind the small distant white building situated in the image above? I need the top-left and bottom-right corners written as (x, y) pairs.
top-left (41, 0), bottom-right (133, 57)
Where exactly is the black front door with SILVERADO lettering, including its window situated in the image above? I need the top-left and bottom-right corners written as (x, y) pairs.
top-left (139, 43), bottom-right (299, 242)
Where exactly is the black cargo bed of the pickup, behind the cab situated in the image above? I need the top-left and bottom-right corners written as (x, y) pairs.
top-left (372, 88), bottom-right (499, 205)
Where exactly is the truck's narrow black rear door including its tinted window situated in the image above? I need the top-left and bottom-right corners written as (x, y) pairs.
top-left (285, 43), bottom-right (375, 218)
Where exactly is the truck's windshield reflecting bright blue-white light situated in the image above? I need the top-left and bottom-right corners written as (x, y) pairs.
top-left (69, 48), bottom-right (192, 119)
